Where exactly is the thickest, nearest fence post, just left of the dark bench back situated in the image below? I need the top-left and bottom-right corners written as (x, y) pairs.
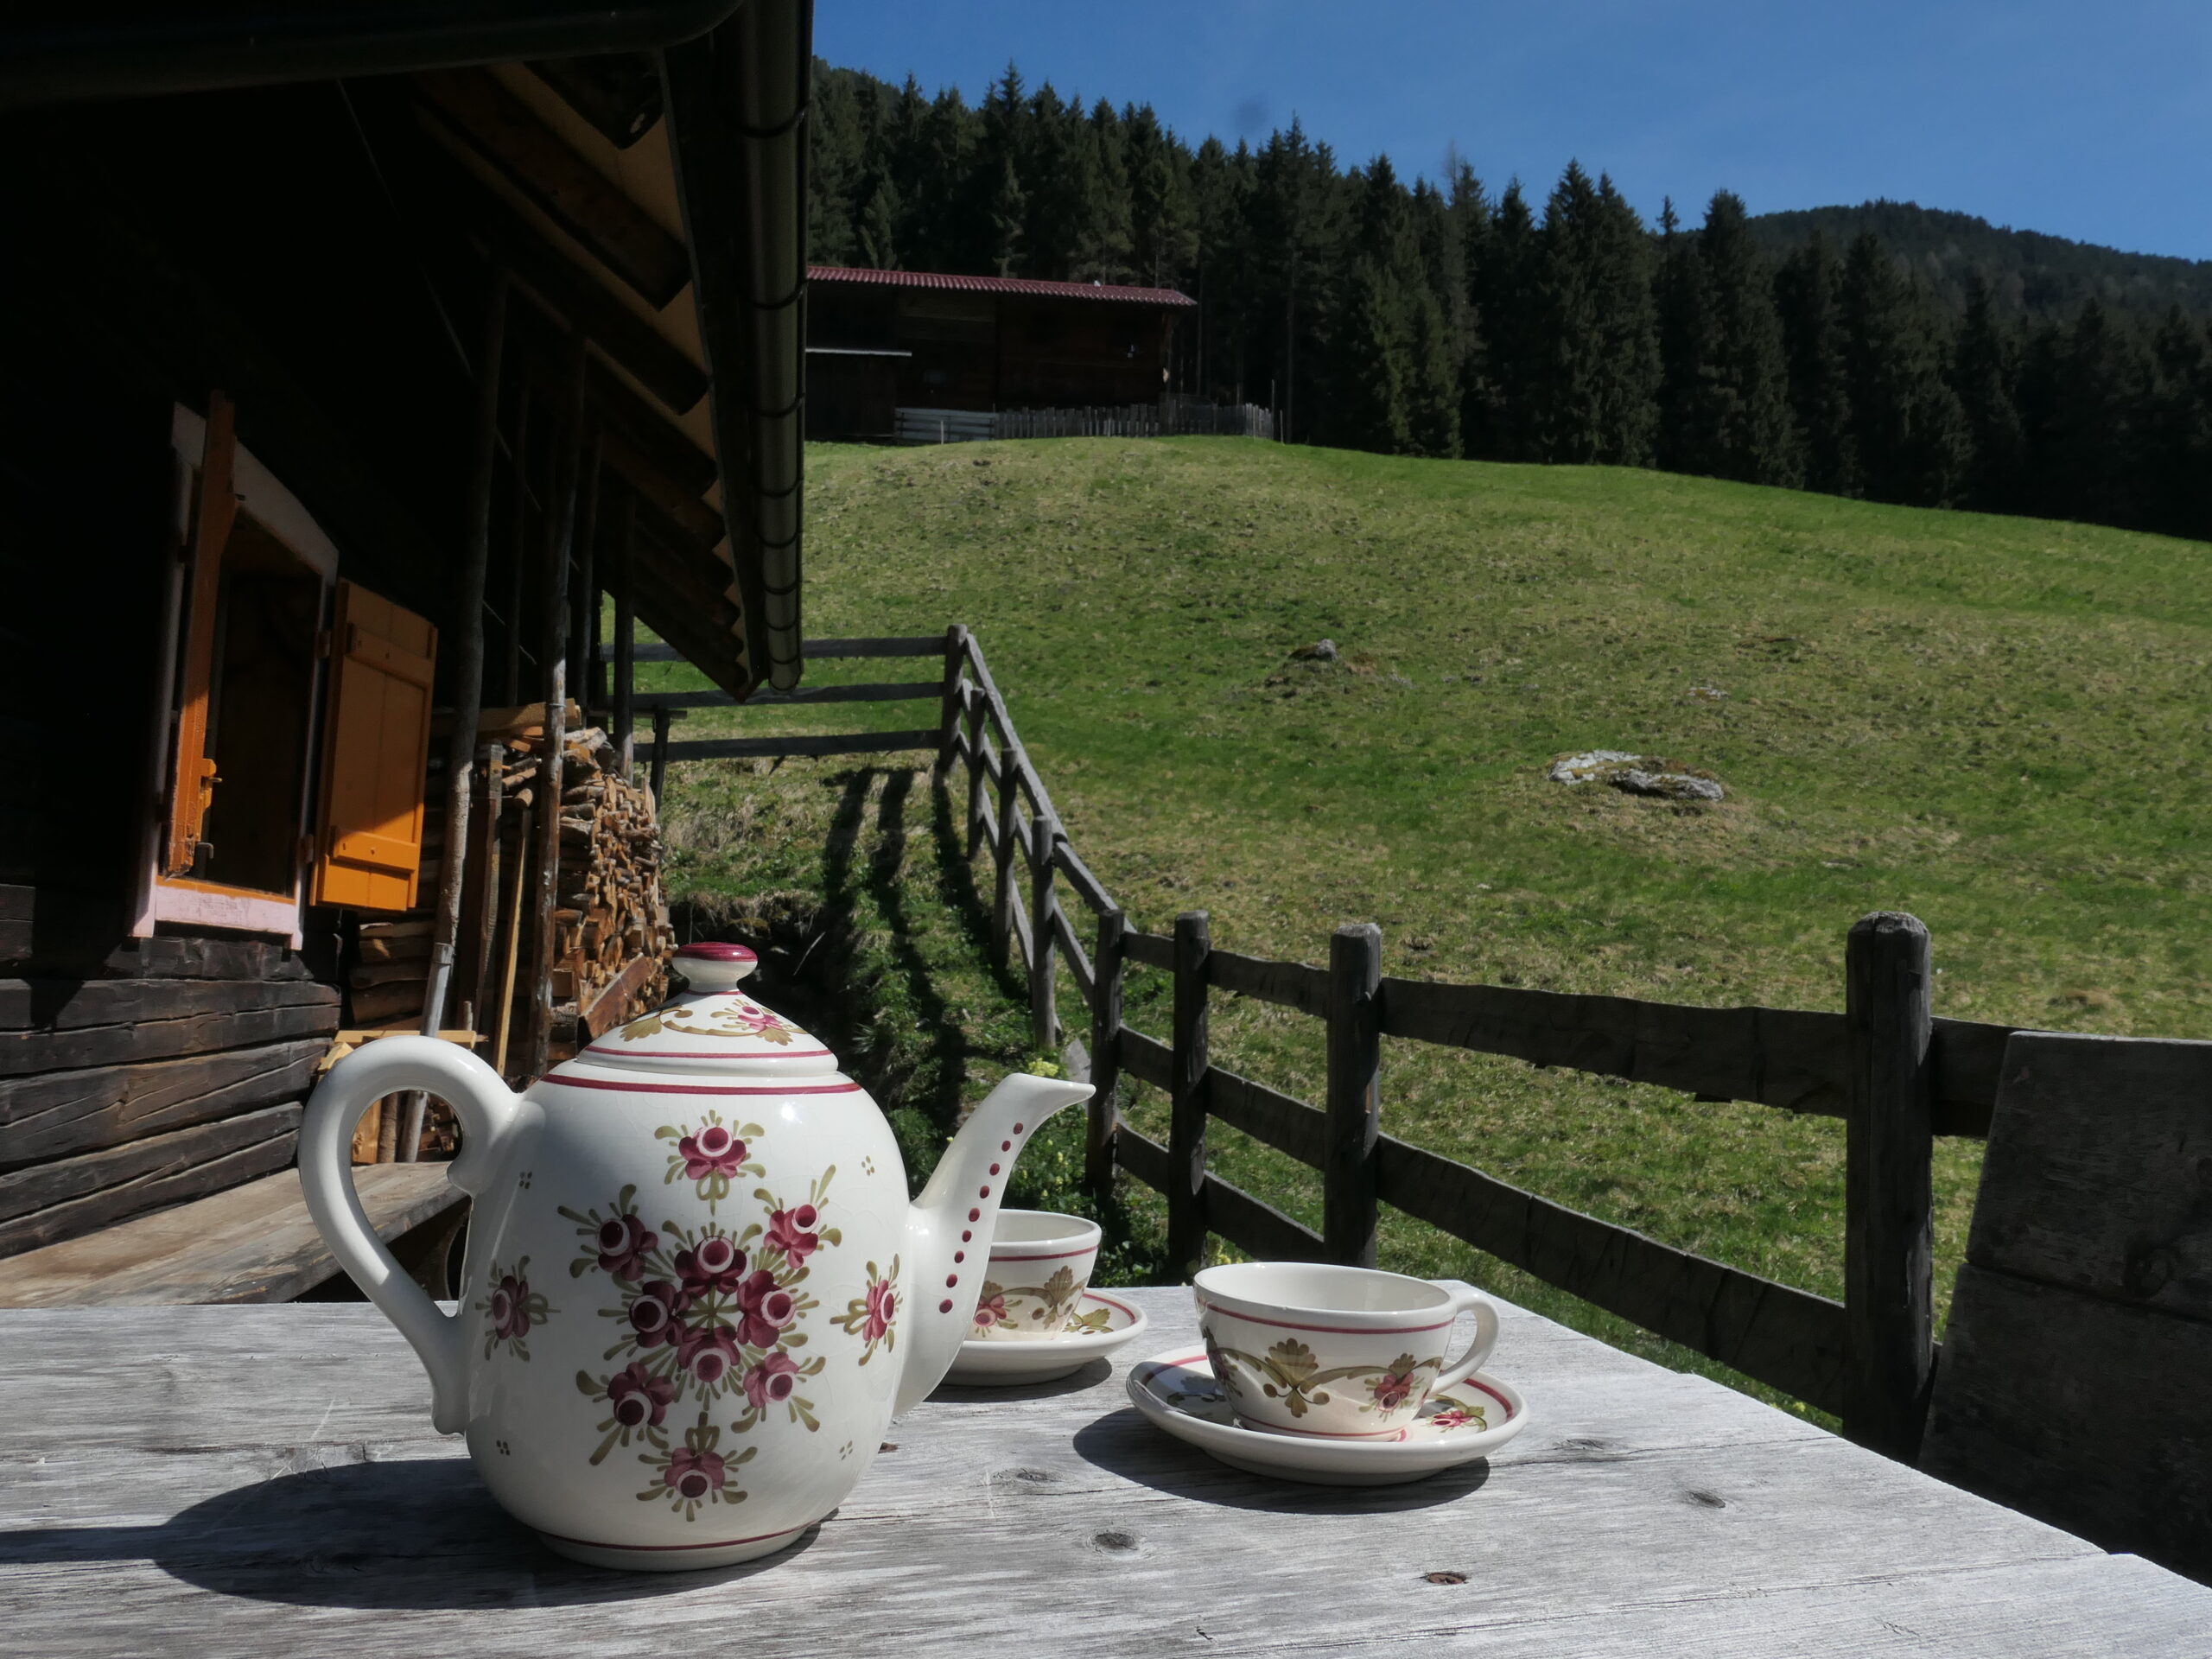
top-left (1842, 912), bottom-right (1936, 1462)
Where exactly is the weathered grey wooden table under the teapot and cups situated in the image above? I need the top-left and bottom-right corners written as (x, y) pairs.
top-left (0, 1289), bottom-right (2212, 1659)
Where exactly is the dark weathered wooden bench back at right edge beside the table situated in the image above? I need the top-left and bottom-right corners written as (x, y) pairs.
top-left (1920, 1033), bottom-right (2212, 1580)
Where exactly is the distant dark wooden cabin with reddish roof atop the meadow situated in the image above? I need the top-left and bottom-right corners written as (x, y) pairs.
top-left (807, 265), bottom-right (1192, 438)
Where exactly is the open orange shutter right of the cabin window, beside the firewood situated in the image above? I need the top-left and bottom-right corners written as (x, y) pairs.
top-left (315, 582), bottom-right (438, 909)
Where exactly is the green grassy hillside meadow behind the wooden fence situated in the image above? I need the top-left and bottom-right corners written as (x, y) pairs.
top-left (666, 440), bottom-right (2212, 1415)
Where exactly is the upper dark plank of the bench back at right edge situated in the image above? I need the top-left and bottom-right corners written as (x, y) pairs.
top-left (1967, 1033), bottom-right (2212, 1319)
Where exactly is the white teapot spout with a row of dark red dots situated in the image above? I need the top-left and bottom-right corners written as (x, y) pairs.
top-left (893, 1071), bottom-right (1090, 1414)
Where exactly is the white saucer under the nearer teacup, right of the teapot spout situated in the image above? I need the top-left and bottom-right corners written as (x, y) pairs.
top-left (1128, 1347), bottom-right (1529, 1486)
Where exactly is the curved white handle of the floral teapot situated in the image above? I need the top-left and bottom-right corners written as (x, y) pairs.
top-left (299, 1038), bottom-right (522, 1433)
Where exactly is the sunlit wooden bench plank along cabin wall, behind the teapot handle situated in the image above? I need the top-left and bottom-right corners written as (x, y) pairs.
top-left (0, 1164), bottom-right (467, 1307)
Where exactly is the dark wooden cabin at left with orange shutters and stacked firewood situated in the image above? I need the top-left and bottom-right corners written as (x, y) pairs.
top-left (0, 0), bottom-right (812, 1303)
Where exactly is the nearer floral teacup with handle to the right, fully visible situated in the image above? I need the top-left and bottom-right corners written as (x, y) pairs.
top-left (1192, 1261), bottom-right (1497, 1440)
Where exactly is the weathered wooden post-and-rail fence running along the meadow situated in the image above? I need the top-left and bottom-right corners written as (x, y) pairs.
top-left (639, 626), bottom-right (2013, 1460)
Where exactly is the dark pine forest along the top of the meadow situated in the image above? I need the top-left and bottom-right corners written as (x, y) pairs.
top-left (810, 64), bottom-right (2212, 540)
